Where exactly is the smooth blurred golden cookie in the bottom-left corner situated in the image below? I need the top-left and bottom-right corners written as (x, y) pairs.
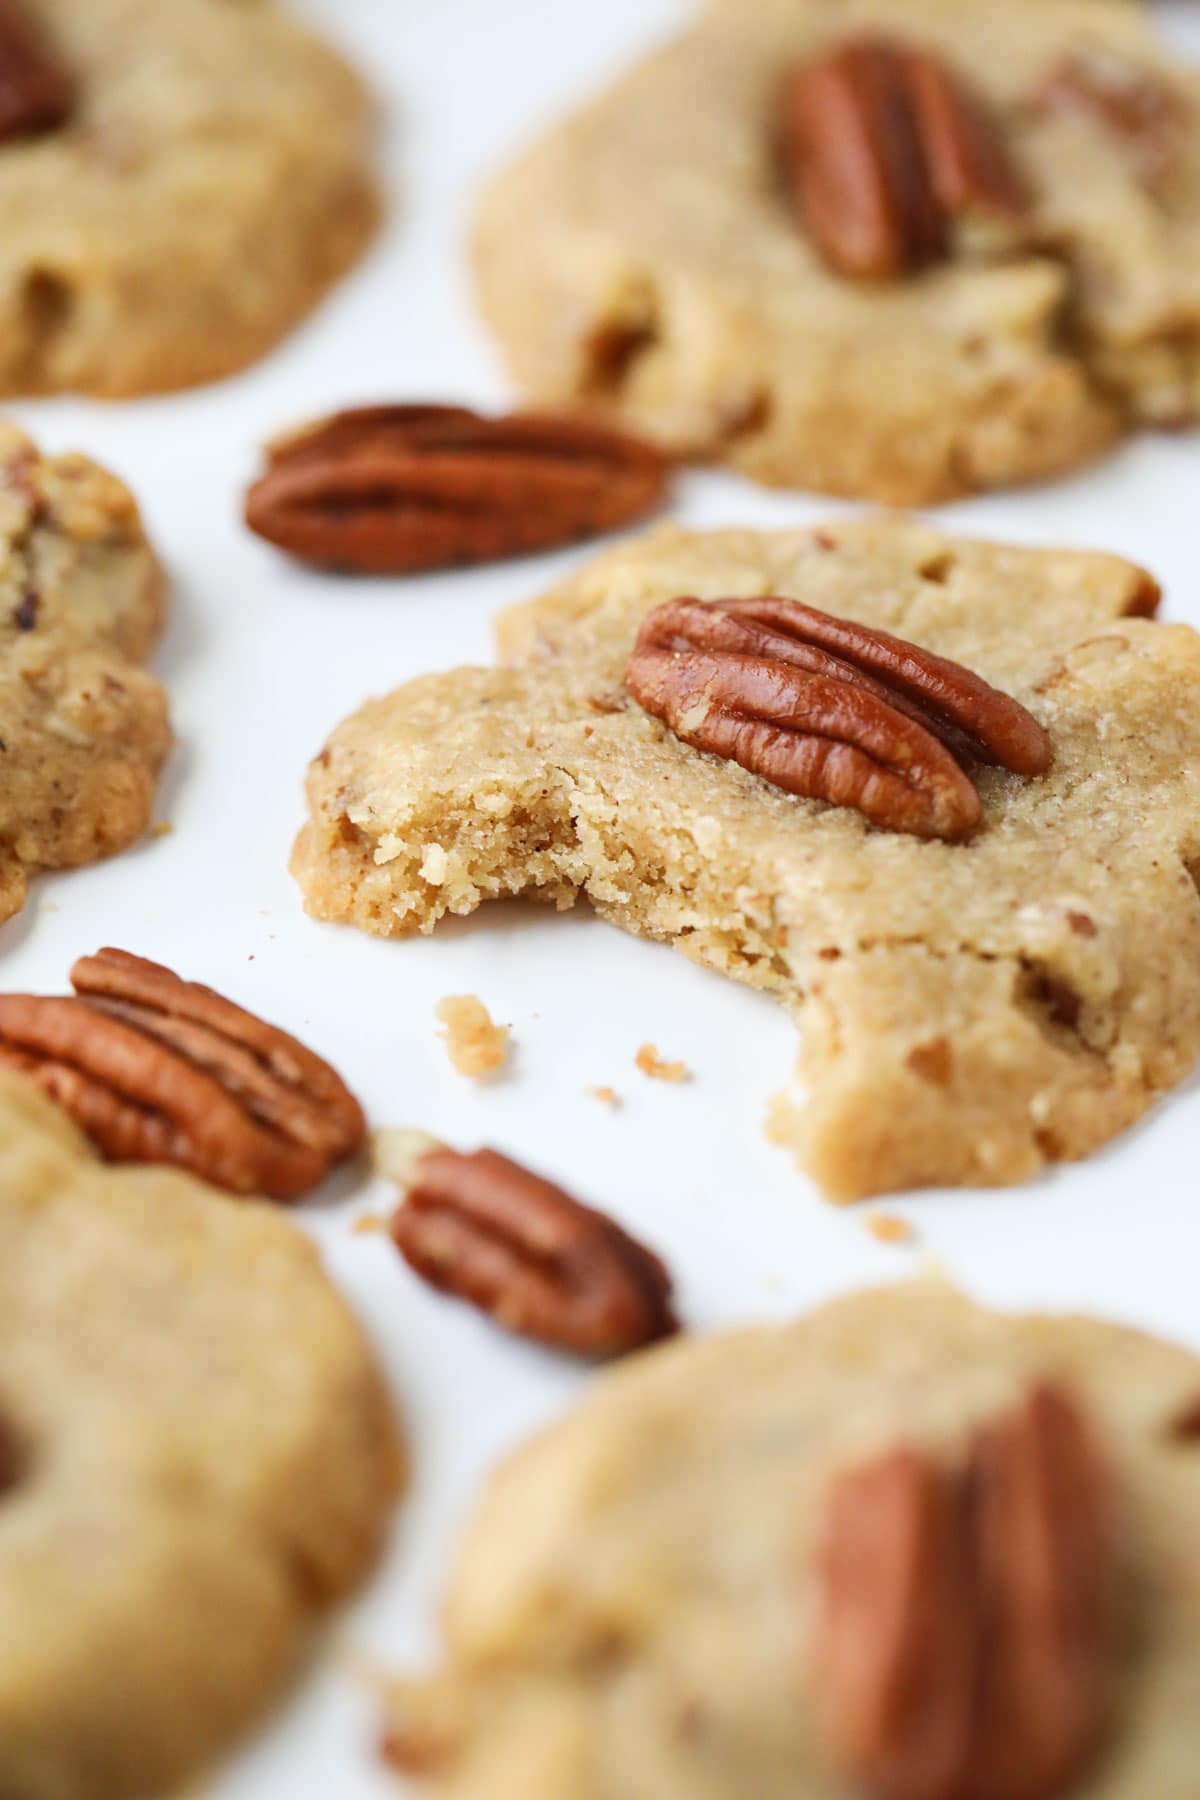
top-left (0, 1076), bottom-right (399, 1800)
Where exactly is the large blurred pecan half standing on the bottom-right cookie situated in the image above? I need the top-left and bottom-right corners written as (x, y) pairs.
top-left (817, 1384), bottom-right (1121, 1800)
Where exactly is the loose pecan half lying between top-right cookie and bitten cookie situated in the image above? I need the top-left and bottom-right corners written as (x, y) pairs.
top-left (246, 405), bottom-right (666, 574)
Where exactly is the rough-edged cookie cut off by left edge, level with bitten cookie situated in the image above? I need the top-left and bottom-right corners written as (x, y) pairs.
top-left (0, 421), bottom-right (171, 920)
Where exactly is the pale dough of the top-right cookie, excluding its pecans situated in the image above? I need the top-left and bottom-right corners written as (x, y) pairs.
top-left (475, 0), bottom-right (1200, 504)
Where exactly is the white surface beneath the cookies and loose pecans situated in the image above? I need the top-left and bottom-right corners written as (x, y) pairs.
top-left (0, 0), bottom-right (1200, 1800)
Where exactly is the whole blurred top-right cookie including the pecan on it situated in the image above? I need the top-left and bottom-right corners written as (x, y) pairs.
top-left (475, 0), bottom-right (1200, 506)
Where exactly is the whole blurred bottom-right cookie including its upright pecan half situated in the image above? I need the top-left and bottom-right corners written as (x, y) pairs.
top-left (390, 1283), bottom-right (1200, 1800)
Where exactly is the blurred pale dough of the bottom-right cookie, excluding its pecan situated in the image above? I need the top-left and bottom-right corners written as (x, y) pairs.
top-left (383, 1282), bottom-right (1200, 1800)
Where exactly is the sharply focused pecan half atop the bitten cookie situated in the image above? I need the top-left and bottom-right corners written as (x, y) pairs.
top-left (624, 596), bottom-right (1051, 839)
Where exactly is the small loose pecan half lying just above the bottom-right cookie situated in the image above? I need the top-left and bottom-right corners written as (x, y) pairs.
top-left (392, 1147), bottom-right (678, 1355)
